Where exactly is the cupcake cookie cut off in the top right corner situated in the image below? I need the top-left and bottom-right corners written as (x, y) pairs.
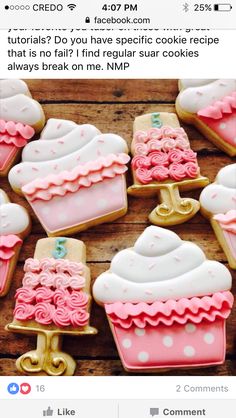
top-left (176, 80), bottom-right (236, 156)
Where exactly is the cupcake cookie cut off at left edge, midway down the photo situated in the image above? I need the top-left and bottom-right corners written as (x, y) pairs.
top-left (0, 189), bottom-right (31, 297)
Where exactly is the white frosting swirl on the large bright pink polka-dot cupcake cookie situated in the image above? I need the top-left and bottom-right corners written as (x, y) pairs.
top-left (93, 226), bottom-right (232, 303)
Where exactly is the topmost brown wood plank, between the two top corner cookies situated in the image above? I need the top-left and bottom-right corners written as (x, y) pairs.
top-left (25, 79), bottom-right (178, 103)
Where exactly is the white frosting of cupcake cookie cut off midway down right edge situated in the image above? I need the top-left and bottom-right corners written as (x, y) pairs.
top-left (200, 164), bottom-right (236, 214)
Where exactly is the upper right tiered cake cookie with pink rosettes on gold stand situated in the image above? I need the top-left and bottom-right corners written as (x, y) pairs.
top-left (128, 113), bottom-right (208, 226)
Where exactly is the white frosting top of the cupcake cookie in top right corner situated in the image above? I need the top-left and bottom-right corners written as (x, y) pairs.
top-left (177, 79), bottom-right (236, 113)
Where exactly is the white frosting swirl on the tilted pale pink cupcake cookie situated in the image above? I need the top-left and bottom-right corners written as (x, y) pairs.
top-left (9, 119), bottom-right (128, 190)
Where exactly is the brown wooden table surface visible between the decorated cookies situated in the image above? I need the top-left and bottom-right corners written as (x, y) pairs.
top-left (0, 80), bottom-right (236, 376)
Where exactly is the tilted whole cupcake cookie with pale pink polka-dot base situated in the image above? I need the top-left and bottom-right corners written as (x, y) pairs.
top-left (9, 119), bottom-right (129, 236)
